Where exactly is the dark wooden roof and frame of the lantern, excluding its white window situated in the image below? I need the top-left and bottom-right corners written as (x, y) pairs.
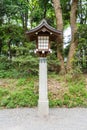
top-left (26, 19), bottom-right (62, 57)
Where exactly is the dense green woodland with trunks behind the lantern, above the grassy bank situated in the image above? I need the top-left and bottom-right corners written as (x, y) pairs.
top-left (0, 0), bottom-right (87, 74)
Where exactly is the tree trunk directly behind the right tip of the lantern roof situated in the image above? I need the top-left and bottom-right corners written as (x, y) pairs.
top-left (53, 0), bottom-right (65, 73)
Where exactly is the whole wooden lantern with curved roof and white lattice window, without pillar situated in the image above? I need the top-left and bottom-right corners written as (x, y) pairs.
top-left (26, 19), bottom-right (62, 57)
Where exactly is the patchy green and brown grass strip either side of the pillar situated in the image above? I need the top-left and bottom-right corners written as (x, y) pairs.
top-left (0, 74), bottom-right (87, 108)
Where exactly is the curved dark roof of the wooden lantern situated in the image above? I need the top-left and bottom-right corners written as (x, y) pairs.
top-left (26, 19), bottom-right (62, 41)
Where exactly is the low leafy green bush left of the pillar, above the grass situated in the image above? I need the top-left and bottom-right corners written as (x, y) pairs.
top-left (0, 55), bottom-right (39, 78)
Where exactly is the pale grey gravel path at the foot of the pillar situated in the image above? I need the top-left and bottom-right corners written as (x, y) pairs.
top-left (0, 108), bottom-right (87, 130)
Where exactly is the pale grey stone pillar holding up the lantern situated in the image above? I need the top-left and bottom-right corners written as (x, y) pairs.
top-left (38, 57), bottom-right (49, 116)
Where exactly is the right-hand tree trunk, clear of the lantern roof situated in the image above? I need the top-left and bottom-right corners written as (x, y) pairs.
top-left (67, 0), bottom-right (78, 71)
